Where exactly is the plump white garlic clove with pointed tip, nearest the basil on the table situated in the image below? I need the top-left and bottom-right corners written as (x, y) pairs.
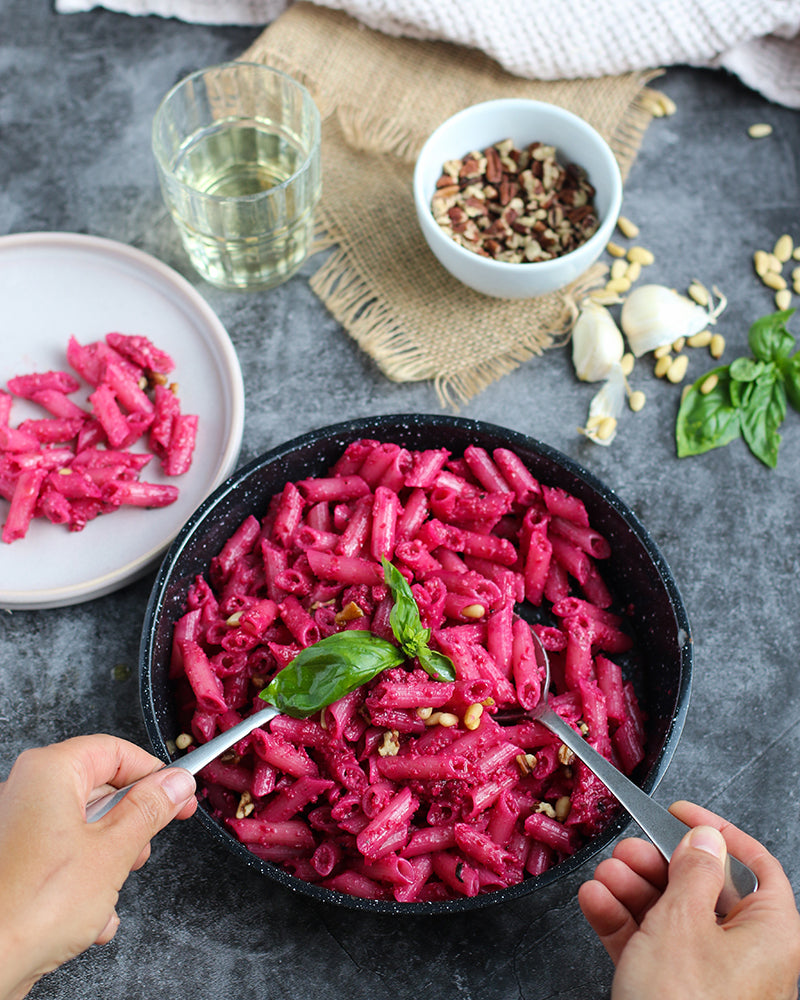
top-left (620, 285), bottom-right (727, 358)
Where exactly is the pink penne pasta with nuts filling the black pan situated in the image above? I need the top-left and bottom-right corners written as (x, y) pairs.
top-left (171, 440), bottom-right (645, 902)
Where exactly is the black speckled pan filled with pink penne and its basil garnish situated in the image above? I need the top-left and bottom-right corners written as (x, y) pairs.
top-left (140, 414), bottom-right (692, 914)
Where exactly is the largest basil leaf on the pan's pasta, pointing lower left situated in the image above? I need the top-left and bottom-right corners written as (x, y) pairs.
top-left (260, 629), bottom-right (406, 719)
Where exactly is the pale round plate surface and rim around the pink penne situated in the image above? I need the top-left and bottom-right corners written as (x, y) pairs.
top-left (0, 233), bottom-right (244, 608)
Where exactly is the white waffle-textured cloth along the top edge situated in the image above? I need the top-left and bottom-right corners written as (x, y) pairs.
top-left (56, 0), bottom-right (800, 108)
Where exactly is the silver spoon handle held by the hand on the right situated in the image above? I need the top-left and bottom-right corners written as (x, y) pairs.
top-left (536, 706), bottom-right (758, 916)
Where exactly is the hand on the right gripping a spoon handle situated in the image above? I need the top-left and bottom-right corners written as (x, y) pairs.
top-left (578, 802), bottom-right (800, 1000)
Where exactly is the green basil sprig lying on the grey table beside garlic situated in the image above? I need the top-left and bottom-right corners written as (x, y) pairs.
top-left (675, 309), bottom-right (800, 469)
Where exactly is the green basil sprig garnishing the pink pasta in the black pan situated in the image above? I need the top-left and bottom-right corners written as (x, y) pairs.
top-left (260, 559), bottom-right (455, 719)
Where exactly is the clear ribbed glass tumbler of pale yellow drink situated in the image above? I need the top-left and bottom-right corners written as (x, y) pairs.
top-left (153, 62), bottom-right (321, 290)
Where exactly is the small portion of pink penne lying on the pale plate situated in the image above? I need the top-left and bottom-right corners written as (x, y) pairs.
top-left (0, 333), bottom-right (198, 544)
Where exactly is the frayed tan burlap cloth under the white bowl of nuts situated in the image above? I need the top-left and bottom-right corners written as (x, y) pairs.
top-left (242, 3), bottom-right (654, 405)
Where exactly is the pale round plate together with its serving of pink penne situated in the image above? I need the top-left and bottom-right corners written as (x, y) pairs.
top-left (0, 233), bottom-right (244, 608)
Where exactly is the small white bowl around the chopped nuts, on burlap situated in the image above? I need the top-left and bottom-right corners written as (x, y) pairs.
top-left (414, 98), bottom-right (622, 299)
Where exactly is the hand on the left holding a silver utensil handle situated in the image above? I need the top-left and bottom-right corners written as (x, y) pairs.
top-left (0, 735), bottom-right (197, 1000)
